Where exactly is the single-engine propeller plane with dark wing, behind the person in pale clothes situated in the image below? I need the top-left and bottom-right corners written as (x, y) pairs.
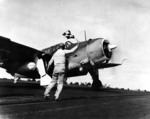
top-left (0, 32), bottom-right (121, 89)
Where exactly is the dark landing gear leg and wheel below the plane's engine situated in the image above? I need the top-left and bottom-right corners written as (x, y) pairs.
top-left (89, 68), bottom-right (102, 90)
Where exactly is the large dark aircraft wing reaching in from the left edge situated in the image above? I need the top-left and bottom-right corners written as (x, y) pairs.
top-left (0, 36), bottom-right (46, 72)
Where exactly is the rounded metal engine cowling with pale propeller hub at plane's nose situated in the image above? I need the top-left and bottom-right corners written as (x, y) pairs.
top-left (87, 38), bottom-right (117, 64)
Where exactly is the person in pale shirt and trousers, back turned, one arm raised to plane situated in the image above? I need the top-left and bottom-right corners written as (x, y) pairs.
top-left (44, 40), bottom-right (79, 101)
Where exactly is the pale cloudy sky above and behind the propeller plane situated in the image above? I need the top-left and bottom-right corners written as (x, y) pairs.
top-left (0, 0), bottom-right (150, 90)
